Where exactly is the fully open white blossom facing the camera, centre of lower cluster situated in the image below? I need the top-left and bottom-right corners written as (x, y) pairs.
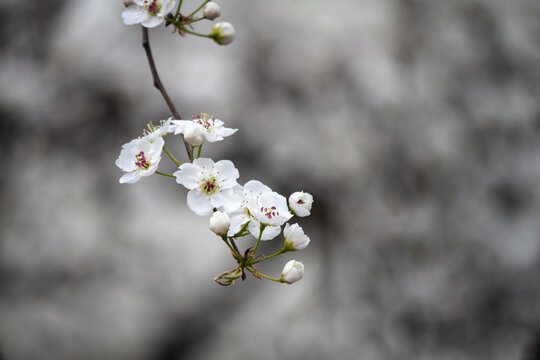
top-left (174, 158), bottom-right (241, 216)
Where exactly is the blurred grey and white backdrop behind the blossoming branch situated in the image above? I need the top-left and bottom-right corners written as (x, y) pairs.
top-left (0, 0), bottom-right (540, 360)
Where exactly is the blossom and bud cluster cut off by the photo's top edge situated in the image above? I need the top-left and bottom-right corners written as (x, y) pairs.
top-left (122, 0), bottom-right (236, 45)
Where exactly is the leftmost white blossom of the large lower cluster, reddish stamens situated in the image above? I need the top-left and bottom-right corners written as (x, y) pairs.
top-left (115, 138), bottom-right (165, 184)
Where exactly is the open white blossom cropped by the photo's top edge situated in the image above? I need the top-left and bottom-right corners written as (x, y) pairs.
top-left (122, 0), bottom-right (176, 28)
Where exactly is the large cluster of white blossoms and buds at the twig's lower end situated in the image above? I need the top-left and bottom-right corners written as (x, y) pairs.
top-left (116, 113), bottom-right (313, 285)
